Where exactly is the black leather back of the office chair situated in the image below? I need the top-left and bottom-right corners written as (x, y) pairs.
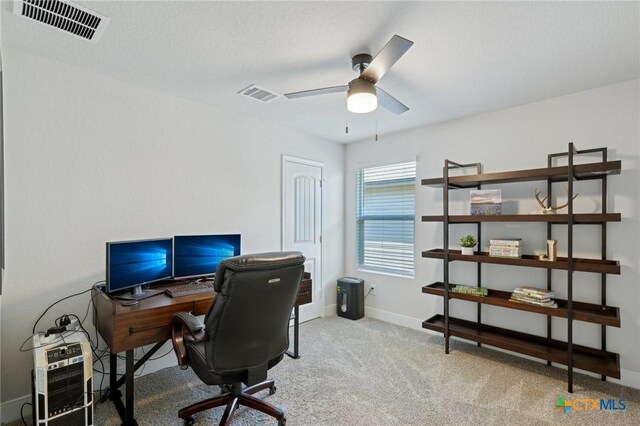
top-left (204, 252), bottom-right (305, 385)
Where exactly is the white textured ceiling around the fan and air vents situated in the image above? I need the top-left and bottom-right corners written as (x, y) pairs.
top-left (1, 1), bottom-right (640, 143)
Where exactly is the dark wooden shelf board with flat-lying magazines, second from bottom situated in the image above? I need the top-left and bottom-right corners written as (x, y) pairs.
top-left (422, 282), bottom-right (620, 327)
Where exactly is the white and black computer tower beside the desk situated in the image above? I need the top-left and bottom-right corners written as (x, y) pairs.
top-left (31, 331), bottom-right (93, 426)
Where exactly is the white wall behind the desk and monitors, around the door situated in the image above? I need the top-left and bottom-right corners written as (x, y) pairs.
top-left (1, 49), bottom-right (345, 420)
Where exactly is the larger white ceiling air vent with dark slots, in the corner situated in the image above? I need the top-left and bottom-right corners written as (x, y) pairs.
top-left (14, 0), bottom-right (109, 43)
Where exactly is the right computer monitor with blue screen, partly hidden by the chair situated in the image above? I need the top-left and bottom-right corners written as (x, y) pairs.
top-left (173, 234), bottom-right (240, 278)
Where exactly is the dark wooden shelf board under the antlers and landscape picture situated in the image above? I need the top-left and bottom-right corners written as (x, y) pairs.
top-left (422, 213), bottom-right (622, 225)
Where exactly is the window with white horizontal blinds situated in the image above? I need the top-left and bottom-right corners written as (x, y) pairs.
top-left (356, 162), bottom-right (416, 277)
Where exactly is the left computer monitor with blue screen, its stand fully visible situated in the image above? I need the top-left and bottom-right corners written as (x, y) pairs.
top-left (106, 238), bottom-right (173, 300)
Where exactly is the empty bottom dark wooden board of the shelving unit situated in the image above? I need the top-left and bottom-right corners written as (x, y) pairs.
top-left (422, 315), bottom-right (620, 379)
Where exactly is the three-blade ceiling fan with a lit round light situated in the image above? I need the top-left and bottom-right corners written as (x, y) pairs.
top-left (284, 35), bottom-right (413, 114)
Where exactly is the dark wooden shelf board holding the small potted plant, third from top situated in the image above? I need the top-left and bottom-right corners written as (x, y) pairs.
top-left (422, 249), bottom-right (620, 275)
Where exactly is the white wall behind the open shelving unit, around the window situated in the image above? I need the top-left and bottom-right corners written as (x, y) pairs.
top-left (345, 80), bottom-right (640, 388)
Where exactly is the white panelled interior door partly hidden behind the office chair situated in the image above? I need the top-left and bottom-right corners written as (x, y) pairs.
top-left (282, 156), bottom-right (324, 321)
